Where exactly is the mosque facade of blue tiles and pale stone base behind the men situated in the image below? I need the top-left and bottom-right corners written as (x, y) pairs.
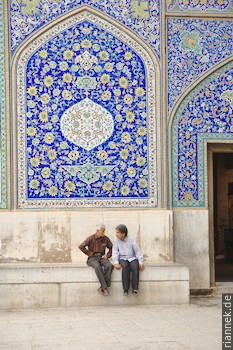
top-left (0, 0), bottom-right (233, 304)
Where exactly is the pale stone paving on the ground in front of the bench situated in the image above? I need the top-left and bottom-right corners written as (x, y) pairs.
top-left (0, 283), bottom-right (230, 350)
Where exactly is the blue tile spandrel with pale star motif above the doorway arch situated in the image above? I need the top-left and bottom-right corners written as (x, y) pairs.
top-left (168, 18), bottom-right (233, 111)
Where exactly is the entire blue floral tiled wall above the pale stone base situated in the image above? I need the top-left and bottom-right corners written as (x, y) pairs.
top-left (0, 0), bottom-right (233, 209)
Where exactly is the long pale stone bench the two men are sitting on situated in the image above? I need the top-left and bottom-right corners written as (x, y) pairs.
top-left (0, 262), bottom-right (189, 310)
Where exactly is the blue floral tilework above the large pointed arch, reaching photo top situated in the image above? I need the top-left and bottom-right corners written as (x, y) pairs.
top-left (10, 0), bottom-right (160, 56)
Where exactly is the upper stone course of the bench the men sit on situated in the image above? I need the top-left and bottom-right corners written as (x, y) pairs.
top-left (0, 262), bottom-right (189, 284)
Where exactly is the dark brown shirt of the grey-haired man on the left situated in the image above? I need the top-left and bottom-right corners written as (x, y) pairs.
top-left (79, 234), bottom-right (112, 258)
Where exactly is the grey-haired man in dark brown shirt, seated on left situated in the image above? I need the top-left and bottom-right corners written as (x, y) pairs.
top-left (79, 224), bottom-right (114, 296)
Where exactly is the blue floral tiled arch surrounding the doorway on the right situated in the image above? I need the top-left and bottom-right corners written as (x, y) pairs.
top-left (170, 57), bottom-right (233, 208)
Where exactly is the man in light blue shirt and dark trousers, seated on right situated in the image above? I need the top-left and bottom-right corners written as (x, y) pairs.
top-left (112, 225), bottom-right (144, 295)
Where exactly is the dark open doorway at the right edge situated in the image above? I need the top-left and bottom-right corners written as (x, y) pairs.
top-left (213, 152), bottom-right (233, 282)
